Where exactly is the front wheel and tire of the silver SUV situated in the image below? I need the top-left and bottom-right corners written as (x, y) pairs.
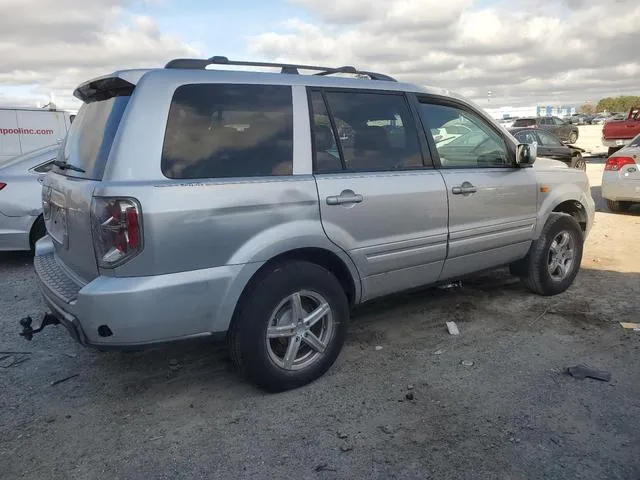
top-left (522, 213), bottom-right (584, 296)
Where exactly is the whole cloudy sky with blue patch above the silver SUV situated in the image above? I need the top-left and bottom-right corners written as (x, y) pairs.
top-left (0, 0), bottom-right (640, 109)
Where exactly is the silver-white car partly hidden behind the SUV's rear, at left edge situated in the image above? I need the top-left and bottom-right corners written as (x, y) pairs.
top-left (0, 144), bottom-right (60, 251)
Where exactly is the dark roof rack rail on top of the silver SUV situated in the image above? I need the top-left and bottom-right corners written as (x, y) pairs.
top-left (164, 56), bottom-right (397, 82)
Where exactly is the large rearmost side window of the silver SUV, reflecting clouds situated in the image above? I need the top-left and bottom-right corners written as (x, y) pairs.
top-left (161, 84), bottom-right (293, 179)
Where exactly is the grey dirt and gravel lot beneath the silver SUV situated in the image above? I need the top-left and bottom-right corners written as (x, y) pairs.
top-left (0, 160), bottom-right (640, 480)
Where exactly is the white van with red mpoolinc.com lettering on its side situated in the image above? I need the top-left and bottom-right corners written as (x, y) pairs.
top-left (0, 107), bottom-right (75, 162)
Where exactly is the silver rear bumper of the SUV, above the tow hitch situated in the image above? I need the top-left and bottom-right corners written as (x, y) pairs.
top-left (34, 237), bottom-right (257, 348)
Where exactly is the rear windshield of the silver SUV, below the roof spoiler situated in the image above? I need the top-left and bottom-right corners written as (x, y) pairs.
top-left (54, 96), bottom-right (131, 180)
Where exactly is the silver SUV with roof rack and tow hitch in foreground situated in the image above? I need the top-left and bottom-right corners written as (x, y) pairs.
top-left (21, 57), bottom-right (594, 391)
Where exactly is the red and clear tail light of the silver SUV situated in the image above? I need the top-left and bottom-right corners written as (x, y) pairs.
top-left (91, 197), bottom-right (142, 268)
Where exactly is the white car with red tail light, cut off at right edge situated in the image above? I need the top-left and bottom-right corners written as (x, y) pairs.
top-left (602, 134), bottom-right (640, 212)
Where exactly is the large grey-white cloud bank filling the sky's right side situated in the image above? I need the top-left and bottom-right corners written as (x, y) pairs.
top-left (250, 0), bottom-right (640, 104)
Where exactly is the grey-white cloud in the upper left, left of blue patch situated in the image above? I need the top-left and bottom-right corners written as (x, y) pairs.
top-left (0, 0), bottom-right (197, 106)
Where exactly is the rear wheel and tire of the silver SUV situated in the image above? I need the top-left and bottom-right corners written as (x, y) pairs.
top-left (228, 261), bottom-right (349, 392)
